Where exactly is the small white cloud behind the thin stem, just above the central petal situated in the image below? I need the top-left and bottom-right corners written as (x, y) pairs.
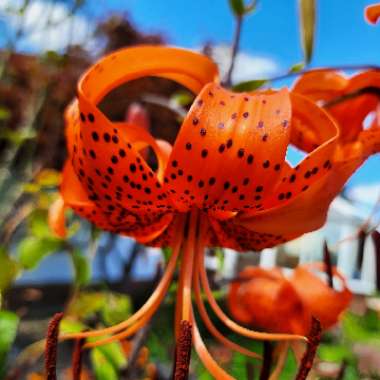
top-left (212, 45), bottom-right (280, 83)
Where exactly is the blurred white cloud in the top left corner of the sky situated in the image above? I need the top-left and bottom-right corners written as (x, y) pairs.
top-left (0, 0), bottom-right (92, 51)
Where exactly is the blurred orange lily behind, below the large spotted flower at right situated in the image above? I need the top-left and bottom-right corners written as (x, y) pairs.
top-left (228, 264), bottom-right (352, 335)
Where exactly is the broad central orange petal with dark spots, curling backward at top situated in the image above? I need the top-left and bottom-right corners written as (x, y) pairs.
top-left (165, 84), bottom-right (291, 214)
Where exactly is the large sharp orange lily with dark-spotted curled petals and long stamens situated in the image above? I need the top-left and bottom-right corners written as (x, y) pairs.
top-left (50, 46), bottom-right (380, 379)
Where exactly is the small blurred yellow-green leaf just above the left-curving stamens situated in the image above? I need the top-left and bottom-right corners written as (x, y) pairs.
top-left (102, 293), bottom-right (132, 326)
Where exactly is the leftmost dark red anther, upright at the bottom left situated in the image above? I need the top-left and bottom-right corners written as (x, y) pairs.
top-left (45, 313), bottom-right (63, 380)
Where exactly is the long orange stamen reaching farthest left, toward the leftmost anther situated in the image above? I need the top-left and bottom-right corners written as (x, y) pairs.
top-left (60, 218), bottom-right (184, 340)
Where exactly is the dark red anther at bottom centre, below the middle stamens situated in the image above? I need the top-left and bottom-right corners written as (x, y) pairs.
top-left (173, 321), bottom-right (192, 380)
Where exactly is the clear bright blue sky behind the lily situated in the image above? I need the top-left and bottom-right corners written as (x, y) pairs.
top-left (0, 0), bottom-right (380, 190)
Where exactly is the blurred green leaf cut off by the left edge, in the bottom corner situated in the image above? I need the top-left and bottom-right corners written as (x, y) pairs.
top-left (0, 310), bottom-right (19, 379)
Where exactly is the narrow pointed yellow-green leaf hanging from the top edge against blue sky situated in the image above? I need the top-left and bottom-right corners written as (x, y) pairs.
top-left (298, 0), bottom-right (316, 63)
